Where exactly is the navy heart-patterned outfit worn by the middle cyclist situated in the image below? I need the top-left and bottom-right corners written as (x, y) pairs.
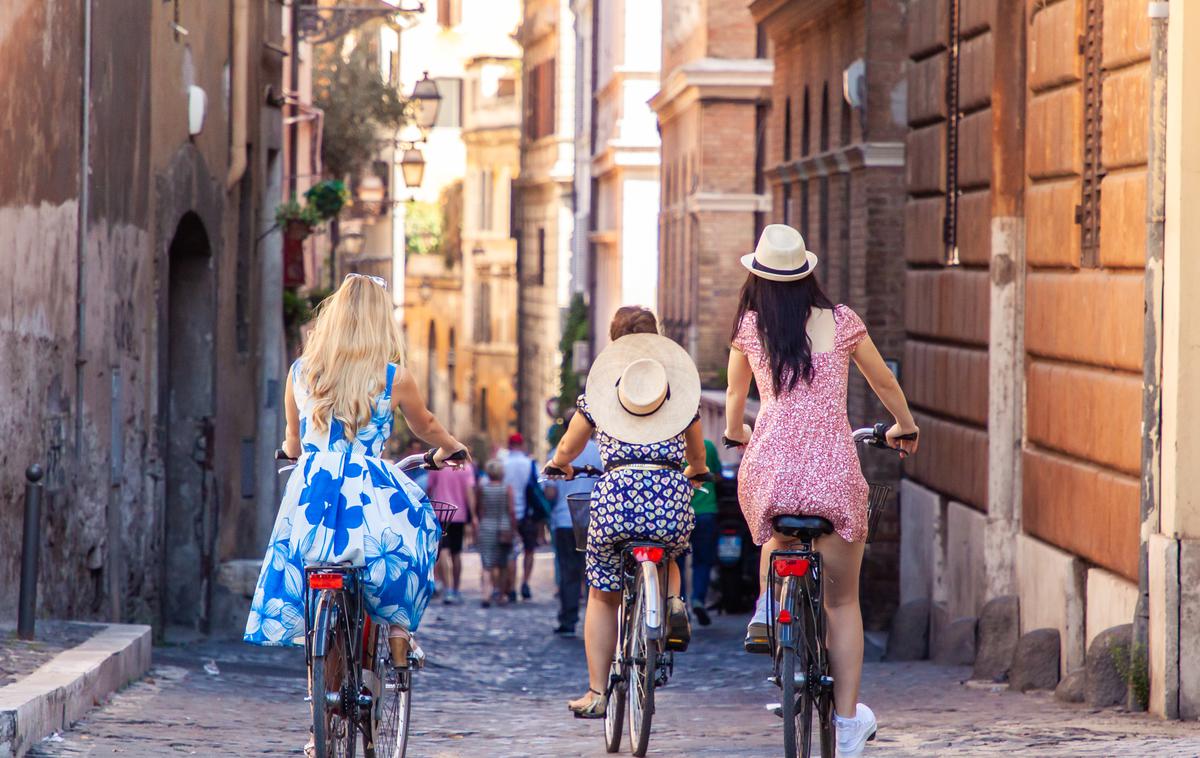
top-left (577, 396), bottom-right (696, 592)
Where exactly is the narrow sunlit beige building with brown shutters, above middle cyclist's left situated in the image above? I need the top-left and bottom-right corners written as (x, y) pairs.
top-left (512, 0), bottom-right (576, 457)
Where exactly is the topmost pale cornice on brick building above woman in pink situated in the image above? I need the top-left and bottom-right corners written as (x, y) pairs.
top-left (649, 58), bottom-right (775, 121)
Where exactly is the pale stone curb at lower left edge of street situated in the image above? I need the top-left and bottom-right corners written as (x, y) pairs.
top-left (0, 624), bottom-right (151, 758)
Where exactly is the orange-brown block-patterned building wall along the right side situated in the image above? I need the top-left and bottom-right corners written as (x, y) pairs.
top-left (900, 0), bottom-right (1200, 717)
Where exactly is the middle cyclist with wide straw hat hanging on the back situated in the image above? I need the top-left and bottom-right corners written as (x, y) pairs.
top-left (547, 306), bottom-right (708, 718)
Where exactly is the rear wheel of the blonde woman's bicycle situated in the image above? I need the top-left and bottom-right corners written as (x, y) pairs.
top-left (311, 590), bottom-right (356, 758)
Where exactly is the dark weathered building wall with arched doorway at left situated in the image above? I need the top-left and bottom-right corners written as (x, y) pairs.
top-left (0, 0), bottom-right (283, 628)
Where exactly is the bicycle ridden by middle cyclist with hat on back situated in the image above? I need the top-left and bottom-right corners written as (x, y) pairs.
top-left (546, 467), bottom-right (712, 758)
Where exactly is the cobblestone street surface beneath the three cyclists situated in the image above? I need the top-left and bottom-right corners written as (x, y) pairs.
top-left (31, 553), bottom-right (1200, 758)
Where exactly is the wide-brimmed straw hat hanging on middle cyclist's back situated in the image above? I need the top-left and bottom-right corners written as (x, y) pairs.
top-left (587, 335), bottom-right (700, 445)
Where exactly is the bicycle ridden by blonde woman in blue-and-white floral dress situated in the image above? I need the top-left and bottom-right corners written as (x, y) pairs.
top-left (275, 450), bottom-right (467, 758)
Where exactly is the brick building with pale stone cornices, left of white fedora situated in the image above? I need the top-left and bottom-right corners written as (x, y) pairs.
top-left (650, 0), bottom-right (774, 383)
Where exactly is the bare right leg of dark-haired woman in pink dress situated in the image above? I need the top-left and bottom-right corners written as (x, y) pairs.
top-left (815, 534), bottom-right (866, 718)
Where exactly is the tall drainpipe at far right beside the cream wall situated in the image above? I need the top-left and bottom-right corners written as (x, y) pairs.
top-left (1129, 2), bottom-right (1169, 710)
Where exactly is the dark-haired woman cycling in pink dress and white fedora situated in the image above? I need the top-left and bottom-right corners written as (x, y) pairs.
top-left (725, 224), bottom-right (918, 756)
